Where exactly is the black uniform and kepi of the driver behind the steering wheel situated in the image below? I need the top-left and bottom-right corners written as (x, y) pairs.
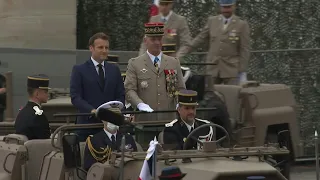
top-left (163, 90), bottom-right (213, 150)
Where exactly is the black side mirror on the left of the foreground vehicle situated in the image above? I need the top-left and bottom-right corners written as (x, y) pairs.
top-left (62, 134), bottom-right (81, 168)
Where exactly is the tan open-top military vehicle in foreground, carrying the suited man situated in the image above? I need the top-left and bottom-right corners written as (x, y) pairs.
top-left (0, 111), bottom-right (290, 180)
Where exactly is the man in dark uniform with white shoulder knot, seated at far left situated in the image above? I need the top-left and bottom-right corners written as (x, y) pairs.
top-left (14, 74), bottom-right (51, 140)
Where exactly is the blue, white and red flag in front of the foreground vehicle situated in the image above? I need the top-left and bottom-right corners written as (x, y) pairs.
top-left (138, 137), bottom-right (158, 180)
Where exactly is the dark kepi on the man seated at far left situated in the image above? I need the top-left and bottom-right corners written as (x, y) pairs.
top-left (27, 74), bottom-right (50, 89)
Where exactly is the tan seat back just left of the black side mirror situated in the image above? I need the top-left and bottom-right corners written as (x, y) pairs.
top-left (24, 139), bottom-right (55, 180)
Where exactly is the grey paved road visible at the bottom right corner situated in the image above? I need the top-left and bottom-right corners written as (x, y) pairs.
top-left (290, 164), bottom-right (316, 180)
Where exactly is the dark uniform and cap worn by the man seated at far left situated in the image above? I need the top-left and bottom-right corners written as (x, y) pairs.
top-left (14, 76), bottom-right (51, 140)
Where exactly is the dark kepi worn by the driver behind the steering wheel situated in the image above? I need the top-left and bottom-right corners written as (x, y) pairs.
top-left (178, 90), bottom-right (198, 106)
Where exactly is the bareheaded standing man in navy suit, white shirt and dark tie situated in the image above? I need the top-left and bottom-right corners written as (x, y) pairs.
top-left (70, 33), bottom-right (125, 141)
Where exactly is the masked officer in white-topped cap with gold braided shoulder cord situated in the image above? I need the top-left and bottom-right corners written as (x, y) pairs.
top-left (84, 101), bottom-right (137, 171)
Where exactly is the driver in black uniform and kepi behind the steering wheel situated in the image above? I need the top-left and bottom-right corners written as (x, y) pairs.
top-left (163, 90), bottom-right (213, 150)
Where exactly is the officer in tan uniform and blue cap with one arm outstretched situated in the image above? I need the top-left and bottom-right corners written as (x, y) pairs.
top-left (177, 0), bottom-right (250, 84)
